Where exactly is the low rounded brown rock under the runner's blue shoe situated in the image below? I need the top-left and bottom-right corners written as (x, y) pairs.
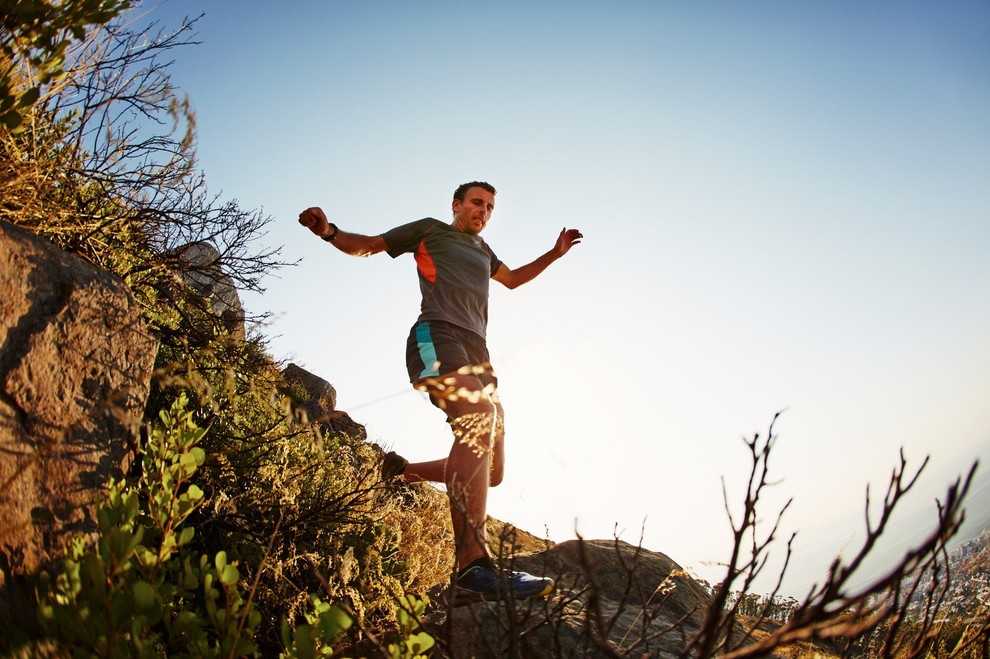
top-left (427, 540), bottom-right (710, 658)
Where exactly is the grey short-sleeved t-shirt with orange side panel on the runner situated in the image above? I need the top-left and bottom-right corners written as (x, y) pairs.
top-left (382, 217), bottom-right (502, 337)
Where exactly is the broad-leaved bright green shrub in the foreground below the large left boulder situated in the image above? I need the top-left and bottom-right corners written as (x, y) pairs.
top-left (38, 396), bottom-right (260, 657)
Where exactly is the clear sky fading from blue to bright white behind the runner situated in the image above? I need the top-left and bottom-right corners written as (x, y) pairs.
top-left (128, 0), bottom-right (990, 590)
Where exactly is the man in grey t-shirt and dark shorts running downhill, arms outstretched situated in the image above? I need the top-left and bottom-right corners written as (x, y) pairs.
top-left (299, 181), bottom-right (582, 598)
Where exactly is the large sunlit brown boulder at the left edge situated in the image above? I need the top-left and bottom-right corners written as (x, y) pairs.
top-left (0, 222), bottom-right (158, 627)
